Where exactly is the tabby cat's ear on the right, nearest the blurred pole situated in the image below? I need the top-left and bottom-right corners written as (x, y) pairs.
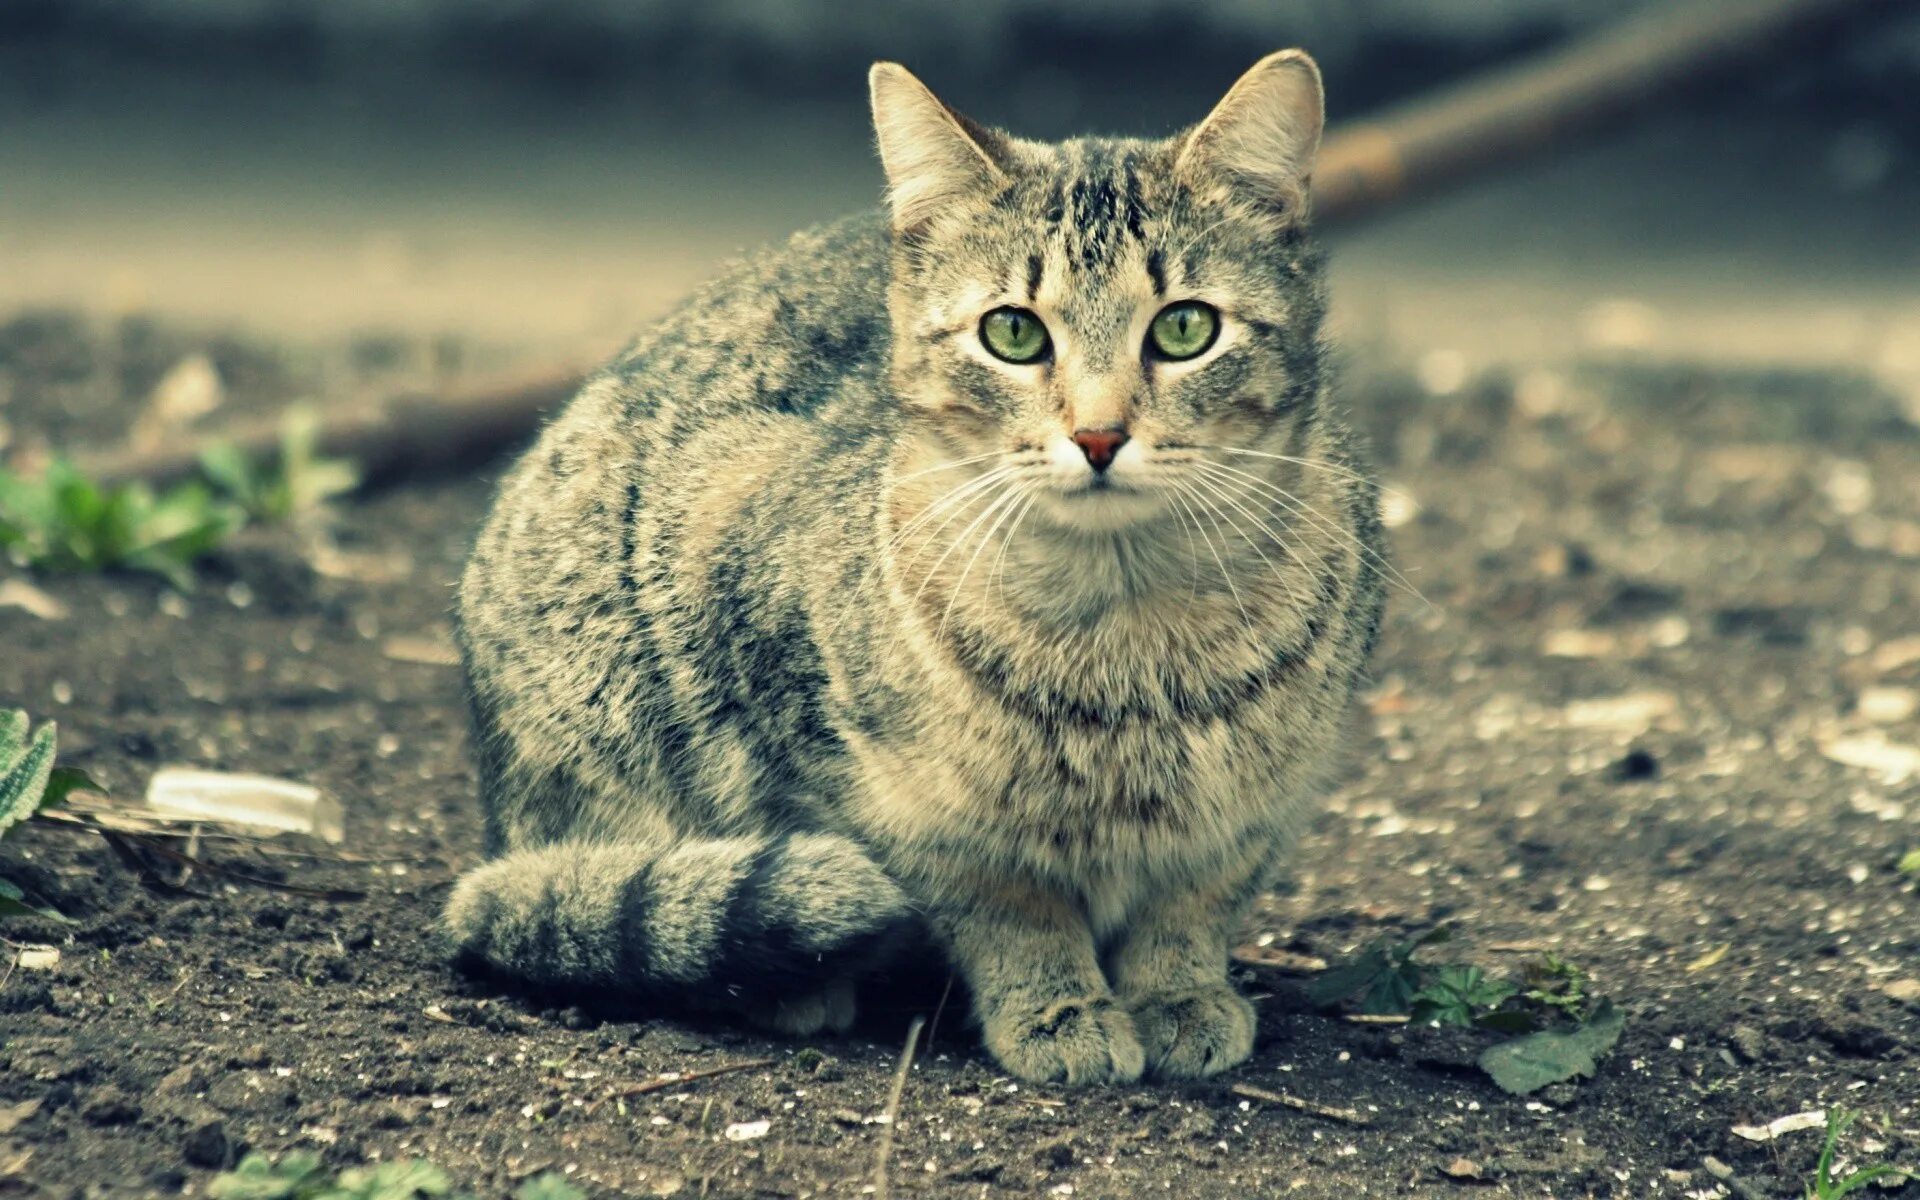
top-left (1175, 50), bottom-right (1327, 217)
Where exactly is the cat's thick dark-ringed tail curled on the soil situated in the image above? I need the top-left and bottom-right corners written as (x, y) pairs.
top-left (444, 833), bottom-right (914, 1010)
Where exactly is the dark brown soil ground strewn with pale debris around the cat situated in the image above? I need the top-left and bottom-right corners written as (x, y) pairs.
top-left (0, 315), bottom-right (1920, 1200)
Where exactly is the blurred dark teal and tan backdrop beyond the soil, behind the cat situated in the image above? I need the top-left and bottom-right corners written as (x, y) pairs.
top-left (0, 0), bottom-right (1920, 382)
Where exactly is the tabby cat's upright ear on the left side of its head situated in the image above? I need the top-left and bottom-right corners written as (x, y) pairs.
top-left (866, 63), bottom-right (1006, 234)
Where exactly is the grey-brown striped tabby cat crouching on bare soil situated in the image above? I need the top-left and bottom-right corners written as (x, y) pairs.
top-left (444, 50), bottom-right (1386, 1083)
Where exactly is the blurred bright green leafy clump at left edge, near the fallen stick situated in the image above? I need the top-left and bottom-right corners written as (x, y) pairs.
top-left (0, 459), bottom-right (246, 589)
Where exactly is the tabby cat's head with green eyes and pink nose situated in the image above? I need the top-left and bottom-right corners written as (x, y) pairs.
top-left (872, 50), bottom-right (1325, 530)
